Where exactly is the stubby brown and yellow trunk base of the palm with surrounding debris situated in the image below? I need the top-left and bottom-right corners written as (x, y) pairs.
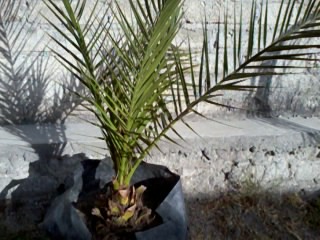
top-left (85, 184), bottom-right (161, 239)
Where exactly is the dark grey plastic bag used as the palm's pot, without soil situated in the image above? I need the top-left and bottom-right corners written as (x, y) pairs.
top-left (40, 160), bottom-right (187, 240)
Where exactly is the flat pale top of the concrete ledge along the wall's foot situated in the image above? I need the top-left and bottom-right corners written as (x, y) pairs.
top-left (0, 117), bottom-right (320, 147)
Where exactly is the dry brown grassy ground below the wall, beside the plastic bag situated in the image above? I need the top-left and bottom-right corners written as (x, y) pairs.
top-left (0, 187), bottom-right (320, 240)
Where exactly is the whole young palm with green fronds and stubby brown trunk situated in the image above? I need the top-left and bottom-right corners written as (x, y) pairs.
top-left (45, 0), bottom-right (320, 232)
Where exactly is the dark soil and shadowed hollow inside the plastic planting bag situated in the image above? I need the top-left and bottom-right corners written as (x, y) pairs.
top-left (74, 177), bottom-right (177, 240)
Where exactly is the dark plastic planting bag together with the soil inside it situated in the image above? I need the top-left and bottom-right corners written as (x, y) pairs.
top-left (41, 160), bottom-right (187, 240)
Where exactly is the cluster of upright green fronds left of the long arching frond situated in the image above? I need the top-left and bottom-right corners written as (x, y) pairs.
top-left (47, 0), bottom-right (185, 187)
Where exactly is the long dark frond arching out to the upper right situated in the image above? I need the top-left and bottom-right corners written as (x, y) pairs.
top-left (138, 1), bottom-right (320, 169)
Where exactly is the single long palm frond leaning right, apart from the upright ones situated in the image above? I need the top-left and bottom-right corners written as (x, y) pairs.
top-left (140, 0), bottom-right (320, 169)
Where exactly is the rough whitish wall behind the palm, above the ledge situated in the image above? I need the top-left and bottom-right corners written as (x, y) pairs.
top-left (0, 0), bottom-right (320, 126)
